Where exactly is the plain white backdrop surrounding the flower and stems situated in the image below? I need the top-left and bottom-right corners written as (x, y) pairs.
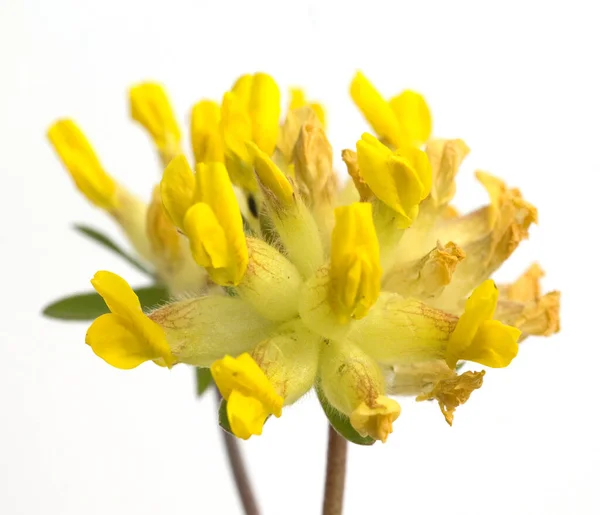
top-left (0, 0), bottom-right (600, 515)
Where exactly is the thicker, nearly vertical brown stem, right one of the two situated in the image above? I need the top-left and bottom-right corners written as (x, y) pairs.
top-left (323, 426), bottom-right (348, 515)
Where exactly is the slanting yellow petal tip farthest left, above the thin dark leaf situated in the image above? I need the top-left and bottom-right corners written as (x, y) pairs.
top-left (48, 120), bottom-right (117, 211)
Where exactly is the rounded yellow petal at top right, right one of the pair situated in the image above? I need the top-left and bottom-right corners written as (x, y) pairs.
top-left (390, 90), bottom-right (431, 146)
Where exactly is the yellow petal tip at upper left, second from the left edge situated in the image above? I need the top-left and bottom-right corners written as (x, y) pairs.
top-left (129, 82), bottom-right (181, 166)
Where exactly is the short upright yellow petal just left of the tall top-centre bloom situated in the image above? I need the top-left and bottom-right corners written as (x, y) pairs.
top-left (190, 100), bottom-right (224, 163)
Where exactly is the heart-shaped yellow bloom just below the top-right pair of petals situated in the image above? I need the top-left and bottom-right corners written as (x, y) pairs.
top-left (356, 134), bottom-right (431, 228)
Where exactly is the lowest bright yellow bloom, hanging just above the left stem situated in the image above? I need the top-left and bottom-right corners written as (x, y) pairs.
top-left (210, 354), bottom-right (283, 440)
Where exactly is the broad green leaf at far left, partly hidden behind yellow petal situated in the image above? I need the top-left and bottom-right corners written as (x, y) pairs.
top-left (43, 286), bottom-right (169, 320)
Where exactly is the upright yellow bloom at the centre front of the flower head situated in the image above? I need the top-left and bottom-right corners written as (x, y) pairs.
top-left (329, 202), bottom-right (381, 322)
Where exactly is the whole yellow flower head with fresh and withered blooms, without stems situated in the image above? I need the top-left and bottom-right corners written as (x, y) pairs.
top-left (48, 73), bottom-right (559, 442)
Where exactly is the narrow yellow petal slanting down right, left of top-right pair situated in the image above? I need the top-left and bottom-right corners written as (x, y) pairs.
top-left (350, 72), bottom-right (402, 147)
